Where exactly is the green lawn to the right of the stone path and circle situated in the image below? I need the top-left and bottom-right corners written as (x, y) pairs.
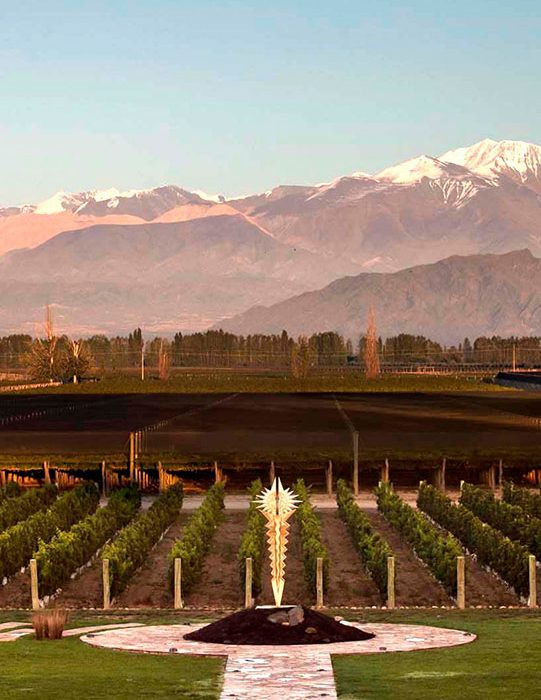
top-left (333, 611), bottom-right (541, 700)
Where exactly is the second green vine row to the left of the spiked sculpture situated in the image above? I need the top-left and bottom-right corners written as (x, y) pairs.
top-left (169, 482), bottom-right (221, 593)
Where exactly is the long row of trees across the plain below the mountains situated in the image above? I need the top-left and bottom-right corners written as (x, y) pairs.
top-left (0, 310), bottom-right (541, 381)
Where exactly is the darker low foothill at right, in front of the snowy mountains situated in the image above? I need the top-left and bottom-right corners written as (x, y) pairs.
top-left (216, 250), bottom-right (541, 343)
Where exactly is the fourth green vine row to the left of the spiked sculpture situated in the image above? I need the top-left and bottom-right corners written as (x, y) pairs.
top-left (34, 487), bottom-right (141, 595)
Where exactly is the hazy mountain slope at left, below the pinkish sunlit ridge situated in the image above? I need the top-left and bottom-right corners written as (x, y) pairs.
top-left (0, 215), bottom-right (358, 332)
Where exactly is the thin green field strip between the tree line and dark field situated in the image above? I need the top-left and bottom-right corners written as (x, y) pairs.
top-left (14, 369), bottom-right (511, 395)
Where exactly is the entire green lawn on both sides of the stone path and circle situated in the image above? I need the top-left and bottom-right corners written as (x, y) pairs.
top-left (0, 610), bottom-right (541, 700)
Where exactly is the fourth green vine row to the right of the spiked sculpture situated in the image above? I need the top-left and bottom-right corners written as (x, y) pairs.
top-left (417, 484), bottom-right (528, 596)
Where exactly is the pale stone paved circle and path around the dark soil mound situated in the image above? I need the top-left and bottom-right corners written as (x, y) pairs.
top-left (81, 623), bottom-right (475, 700)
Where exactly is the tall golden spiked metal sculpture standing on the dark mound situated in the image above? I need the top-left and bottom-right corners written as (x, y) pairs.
top-left (256, 479), bottom-right (299, 606)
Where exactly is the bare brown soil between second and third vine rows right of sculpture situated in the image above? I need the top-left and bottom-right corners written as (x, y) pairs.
top-left (363, 508), bottom-right (453, 606)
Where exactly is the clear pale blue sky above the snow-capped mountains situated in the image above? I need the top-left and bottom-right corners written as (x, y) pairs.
top-left (0, 0), bottom-right (541, 204)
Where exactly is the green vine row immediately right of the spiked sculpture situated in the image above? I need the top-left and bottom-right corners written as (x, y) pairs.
top-left (294, 479), bottom-right (329, 594)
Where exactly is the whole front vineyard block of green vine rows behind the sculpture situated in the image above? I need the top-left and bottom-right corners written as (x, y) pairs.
top-left (0, 479), bottom-right (541, 610)
